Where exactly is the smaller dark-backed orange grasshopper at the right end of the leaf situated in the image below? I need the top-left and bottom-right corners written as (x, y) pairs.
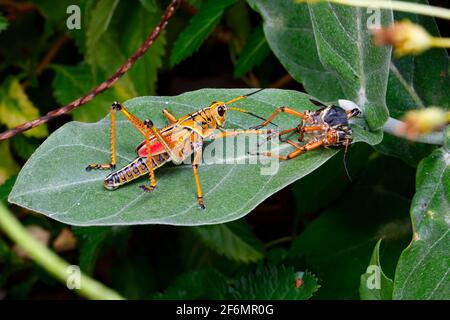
top-left (251, 100), bottom-right (361, 160)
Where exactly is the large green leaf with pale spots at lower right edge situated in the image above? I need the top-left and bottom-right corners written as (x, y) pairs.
top-left (393, 129), bottom-right (450, 299)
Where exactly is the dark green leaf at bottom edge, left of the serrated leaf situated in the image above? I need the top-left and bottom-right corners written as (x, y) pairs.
top-left (152, 268), bottom-right (228, 300)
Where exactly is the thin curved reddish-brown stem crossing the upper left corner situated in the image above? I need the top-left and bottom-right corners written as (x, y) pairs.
top-left (0, 0), bottom-right (182, 141)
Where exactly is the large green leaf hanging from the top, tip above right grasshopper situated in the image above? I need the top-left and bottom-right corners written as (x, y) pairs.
top-left (248, 0), bottom-right (393, 129)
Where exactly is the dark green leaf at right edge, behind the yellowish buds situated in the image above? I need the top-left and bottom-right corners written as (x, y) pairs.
top-left (376, 0), bottom-right (450, 166)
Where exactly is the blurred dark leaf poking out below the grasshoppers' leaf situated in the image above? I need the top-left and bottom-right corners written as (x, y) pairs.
top-left (192, 220), bottom-right (263, 263)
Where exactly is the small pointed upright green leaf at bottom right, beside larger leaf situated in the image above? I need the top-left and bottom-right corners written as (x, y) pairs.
top-left (359, 240), bottom-right (393, 300)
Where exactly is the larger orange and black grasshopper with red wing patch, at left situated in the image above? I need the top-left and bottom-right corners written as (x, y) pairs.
top-left (86, 89), bottom-right (270, 209)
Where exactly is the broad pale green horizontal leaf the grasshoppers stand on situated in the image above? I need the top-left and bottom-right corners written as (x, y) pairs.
top-left (9, 89), bottom-right (379, 225)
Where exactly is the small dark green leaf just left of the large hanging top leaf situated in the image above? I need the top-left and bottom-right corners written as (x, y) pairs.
top-left (234, 26), bottom-right (270, 78)
